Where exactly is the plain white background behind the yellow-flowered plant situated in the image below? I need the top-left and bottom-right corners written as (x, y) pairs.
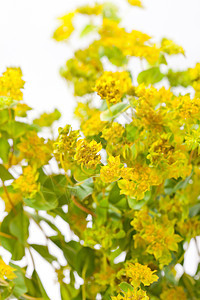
top-left (0, 0), bottom-right (200, 300)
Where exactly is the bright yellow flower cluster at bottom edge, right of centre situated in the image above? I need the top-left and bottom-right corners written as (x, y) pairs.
top-left (125, 262), bottom-right (158, 288)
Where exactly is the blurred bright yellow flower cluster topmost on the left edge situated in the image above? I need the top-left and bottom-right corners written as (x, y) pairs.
top-left (0, 68), bottom-right (25, 100)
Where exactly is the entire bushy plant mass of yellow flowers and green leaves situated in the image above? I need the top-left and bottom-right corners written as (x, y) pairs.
top-left (0, 0), bottom-right (200, 300)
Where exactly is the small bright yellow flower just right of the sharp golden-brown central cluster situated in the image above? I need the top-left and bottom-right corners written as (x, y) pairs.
top-left (100, 155), bottom-right (121, 182)
